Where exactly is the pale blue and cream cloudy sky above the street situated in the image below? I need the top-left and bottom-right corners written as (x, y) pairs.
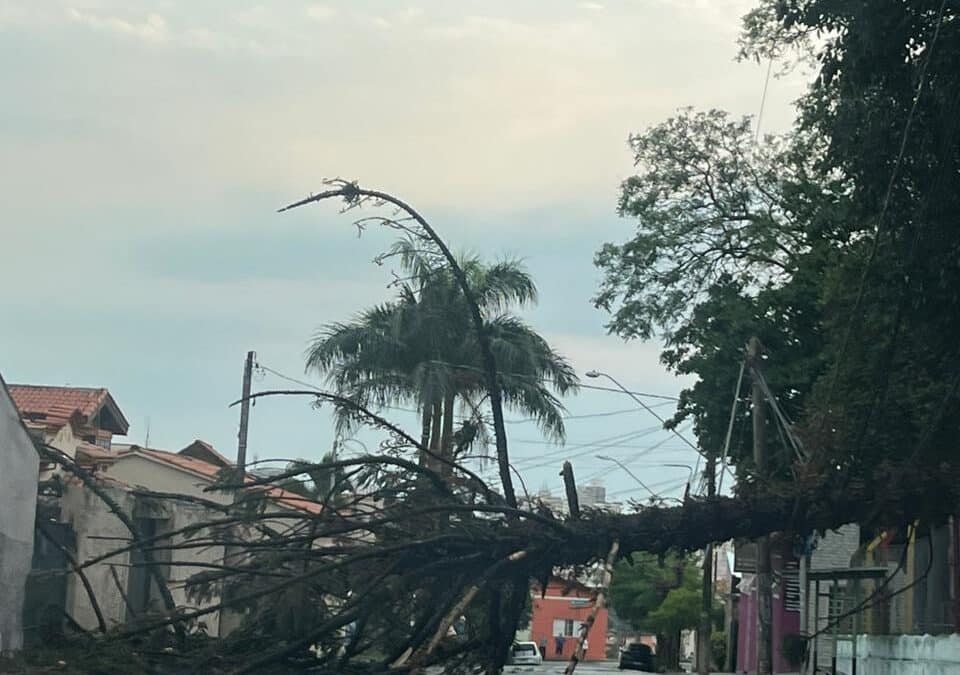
top-left (0, 0), bottom-right (804, 500)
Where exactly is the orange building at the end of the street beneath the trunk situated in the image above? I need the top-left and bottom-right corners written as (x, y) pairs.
top-left (530, 580), bottom-right (608, 661)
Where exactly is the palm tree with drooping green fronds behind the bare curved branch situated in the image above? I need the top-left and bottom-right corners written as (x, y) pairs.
top-left (307, 241), bottom-right (578, 470)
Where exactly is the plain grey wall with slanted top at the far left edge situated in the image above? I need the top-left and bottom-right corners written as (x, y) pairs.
top-left (0, 378), bottom-right (40, 653)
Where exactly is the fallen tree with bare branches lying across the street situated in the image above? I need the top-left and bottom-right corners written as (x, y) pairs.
top-left (15, 181), bottom-right (960, 674)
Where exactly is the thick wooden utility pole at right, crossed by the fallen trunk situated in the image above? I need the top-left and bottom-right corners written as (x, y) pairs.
top-left (747, 337), bottom-right (773, 675)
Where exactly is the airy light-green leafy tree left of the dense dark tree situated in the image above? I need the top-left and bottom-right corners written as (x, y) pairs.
top-left (595, 110), bottom-right (847, 474)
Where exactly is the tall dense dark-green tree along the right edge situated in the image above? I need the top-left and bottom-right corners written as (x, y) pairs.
top-left (742, 0), bottom-right (960, 472)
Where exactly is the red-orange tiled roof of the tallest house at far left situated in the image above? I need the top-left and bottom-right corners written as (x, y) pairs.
top-left (8, 384), bottom-right (129, 434)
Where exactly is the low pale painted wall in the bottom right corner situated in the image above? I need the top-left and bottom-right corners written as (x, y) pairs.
top-left (837, 634), bottom-right (960, 675)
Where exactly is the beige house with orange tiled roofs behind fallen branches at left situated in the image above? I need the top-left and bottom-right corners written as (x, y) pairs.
top-left (7, 385), bottom-right (322, 643)
